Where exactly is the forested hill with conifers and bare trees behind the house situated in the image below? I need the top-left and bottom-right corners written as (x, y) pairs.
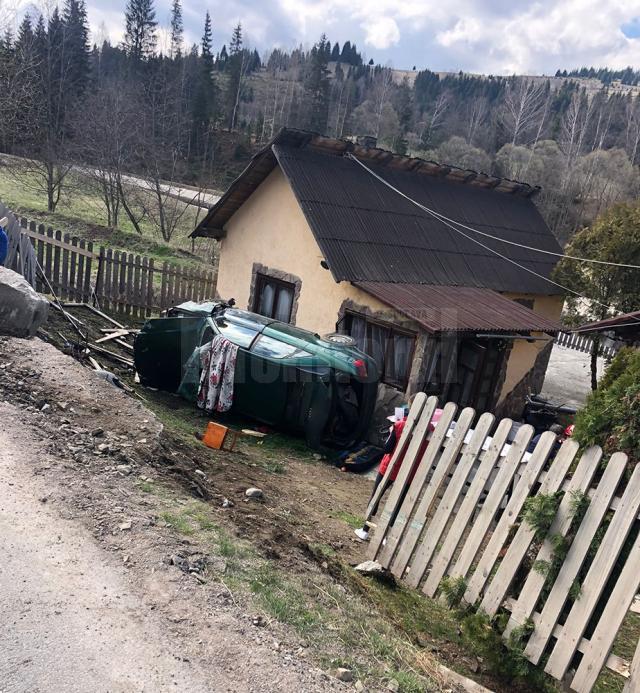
top-left (0, 0), bottom-right (640, 240)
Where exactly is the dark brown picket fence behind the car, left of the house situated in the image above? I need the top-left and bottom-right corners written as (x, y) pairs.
top-left (20, 218), bottom-right (216, 317)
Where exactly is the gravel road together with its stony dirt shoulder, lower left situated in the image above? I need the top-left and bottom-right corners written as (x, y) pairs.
top-left (0, 340), bottom-right (341, 693)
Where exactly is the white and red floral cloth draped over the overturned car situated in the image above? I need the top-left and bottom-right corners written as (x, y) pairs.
top-left (197, 335), bottom-right (238, 411)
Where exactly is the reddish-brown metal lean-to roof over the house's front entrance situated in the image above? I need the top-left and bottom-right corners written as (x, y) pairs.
top-left (354, 282), bottom-right (562, 333)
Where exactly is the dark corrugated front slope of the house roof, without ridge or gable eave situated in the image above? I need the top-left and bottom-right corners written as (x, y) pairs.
top-left (274, 145), bottom-right (560, 294)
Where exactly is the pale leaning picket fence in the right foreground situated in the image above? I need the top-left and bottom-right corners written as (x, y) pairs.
top-left (367, 394), bottom-right (640, 693)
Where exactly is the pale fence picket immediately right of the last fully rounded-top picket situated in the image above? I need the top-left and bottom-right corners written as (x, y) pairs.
top-left (545, 453), bottom-right (640, 679)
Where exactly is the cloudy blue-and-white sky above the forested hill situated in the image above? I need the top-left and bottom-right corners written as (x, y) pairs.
top-left (25, 0), bottom-right (640, 74)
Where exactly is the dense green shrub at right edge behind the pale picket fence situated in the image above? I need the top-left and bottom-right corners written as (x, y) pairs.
top-left (574, 348), bottom-right (640, 462)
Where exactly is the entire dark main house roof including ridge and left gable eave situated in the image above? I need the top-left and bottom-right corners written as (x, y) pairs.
top-left (193, 130), bottom-right (561, 295)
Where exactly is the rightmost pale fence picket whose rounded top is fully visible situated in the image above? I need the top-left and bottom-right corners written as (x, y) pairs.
top-left (524, 454), bottom-right (627, 664)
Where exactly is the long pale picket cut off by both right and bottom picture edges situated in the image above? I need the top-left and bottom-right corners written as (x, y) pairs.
top-left (571, 535), bottom-right (640, 693)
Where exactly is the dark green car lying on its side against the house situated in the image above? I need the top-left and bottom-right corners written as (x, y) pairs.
top-left (134, 302), bottom-right (378, 447)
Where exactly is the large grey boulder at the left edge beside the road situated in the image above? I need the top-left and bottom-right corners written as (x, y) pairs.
top-left (0, 267), bottom-right (49, 338)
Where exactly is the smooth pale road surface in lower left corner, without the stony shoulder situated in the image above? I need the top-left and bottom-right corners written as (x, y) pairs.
top-left (0, 405), bottom-right (218, 693)
